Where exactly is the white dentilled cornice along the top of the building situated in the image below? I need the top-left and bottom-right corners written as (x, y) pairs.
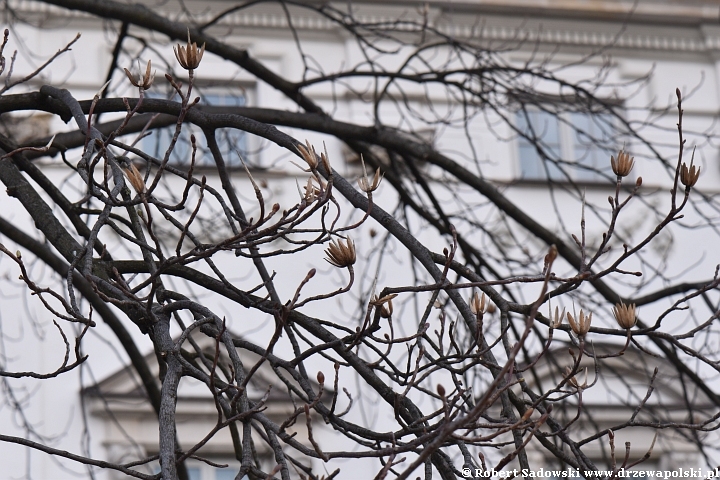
top-left (9, 0), bottom-right (720, 53)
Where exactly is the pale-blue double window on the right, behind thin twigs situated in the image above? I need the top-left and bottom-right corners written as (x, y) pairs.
top-left (516, 109), bottom-right (621, 183)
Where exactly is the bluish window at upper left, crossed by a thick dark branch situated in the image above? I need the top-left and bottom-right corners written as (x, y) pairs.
top-left (143, 88), bottom-right (248, 167)
